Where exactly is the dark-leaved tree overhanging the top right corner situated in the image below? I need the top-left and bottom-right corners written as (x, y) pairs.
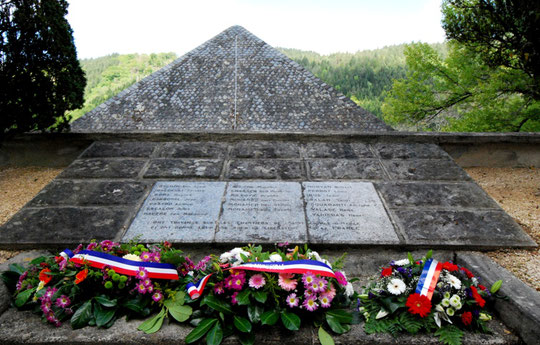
top-left (442, 0), bottom-right (540, 100)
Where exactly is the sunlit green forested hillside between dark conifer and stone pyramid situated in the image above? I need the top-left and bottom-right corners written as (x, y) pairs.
top-left (66, 53), bottom-right (176, 121)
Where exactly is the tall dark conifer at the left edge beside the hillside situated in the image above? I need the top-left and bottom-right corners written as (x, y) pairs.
top-left (0, 0), bottom-right (86, 135)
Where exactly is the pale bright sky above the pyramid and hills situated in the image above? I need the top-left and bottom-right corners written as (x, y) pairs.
top-left (67, 0), bottom-right (444, 59)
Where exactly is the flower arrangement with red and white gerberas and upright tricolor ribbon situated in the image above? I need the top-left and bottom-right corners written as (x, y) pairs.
top-left (359, 251), bottom-right (502, 345)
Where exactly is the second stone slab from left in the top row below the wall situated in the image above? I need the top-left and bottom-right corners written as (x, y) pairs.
top-left (159, 141), bottom-right (227, 158)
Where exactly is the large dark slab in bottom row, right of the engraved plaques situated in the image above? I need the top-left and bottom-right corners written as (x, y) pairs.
top-left (391, 208), bottom-right (536, 248)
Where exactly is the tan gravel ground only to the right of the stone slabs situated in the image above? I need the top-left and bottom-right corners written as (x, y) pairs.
top-left (465, 168), bottom-right (540, 291)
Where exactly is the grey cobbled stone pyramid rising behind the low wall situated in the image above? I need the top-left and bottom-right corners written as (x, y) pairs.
top-left (72, 26), bottom-right (390, 133)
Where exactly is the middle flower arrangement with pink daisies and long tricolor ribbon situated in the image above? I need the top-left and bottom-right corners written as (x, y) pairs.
top-left (186, 244), bottom-right (357, 344)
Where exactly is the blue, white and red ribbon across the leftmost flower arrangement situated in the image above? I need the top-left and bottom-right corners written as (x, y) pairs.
top-left (60, 249), bottom-right (179, 280)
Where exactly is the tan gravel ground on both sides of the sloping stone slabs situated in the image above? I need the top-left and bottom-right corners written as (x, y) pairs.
top-left (0, 167), bottom-right (540, 291)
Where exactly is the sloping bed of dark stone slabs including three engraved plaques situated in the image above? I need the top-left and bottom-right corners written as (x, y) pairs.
top-left (0, 140), bottom-right (535, 248)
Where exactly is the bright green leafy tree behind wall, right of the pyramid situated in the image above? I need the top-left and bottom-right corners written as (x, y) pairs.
top-left (382, 42), bottom-right (540, 132)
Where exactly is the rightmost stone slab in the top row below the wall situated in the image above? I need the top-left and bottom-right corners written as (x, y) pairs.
top-left (372, 143), bottom-right (448, 159)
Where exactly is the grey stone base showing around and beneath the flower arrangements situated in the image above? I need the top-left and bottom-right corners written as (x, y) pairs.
top-left (0, 247), bottom-right (540, 345)
